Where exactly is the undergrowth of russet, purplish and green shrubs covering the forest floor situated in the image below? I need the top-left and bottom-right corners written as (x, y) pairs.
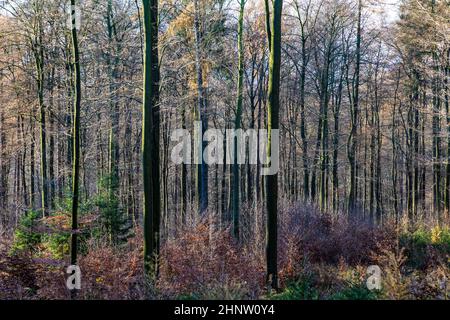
top-left (0, 205), bottom-right (450, 300)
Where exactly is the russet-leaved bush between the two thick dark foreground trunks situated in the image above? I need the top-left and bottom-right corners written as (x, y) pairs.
top-left (158, 221), bottom-right (264, 299)
